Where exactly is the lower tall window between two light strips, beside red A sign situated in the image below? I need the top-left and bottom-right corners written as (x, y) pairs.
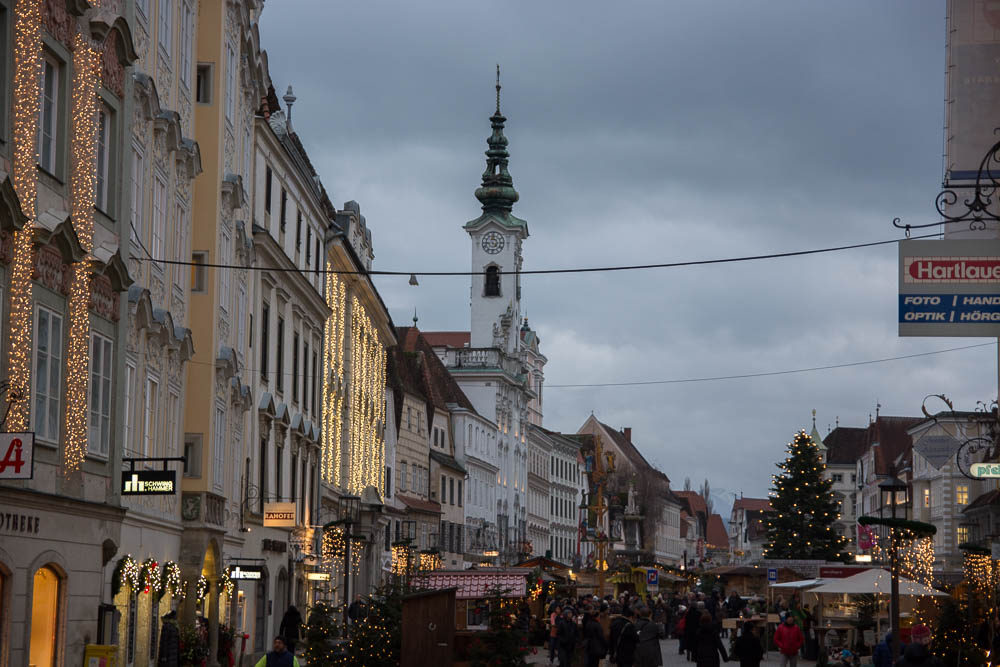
top-left (32, 306), bottom-right (63, 442)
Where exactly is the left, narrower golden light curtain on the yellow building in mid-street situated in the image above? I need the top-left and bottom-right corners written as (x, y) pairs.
top-left (320, 272), bottom-right (347, 486)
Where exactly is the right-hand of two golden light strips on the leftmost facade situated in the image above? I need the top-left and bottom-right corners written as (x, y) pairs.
top-left (63, 35), bottom-right (101, 475)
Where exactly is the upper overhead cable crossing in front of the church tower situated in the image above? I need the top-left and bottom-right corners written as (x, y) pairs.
top-left (137, 234), bottom-right (940, 276)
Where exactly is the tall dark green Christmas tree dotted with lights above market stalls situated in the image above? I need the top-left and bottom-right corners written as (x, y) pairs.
top-left (765, 431), bottom-right (847, 561)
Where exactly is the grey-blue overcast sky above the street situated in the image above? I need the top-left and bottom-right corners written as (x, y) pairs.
top-left (261, 0), bottom-right (996, 513)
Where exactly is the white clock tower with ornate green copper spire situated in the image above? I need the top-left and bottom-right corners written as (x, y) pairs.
top-left (464, 65), bottom-right (528, 355)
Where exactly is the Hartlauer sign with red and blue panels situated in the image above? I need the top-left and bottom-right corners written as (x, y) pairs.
top-left (899, 239), bottom-right (1000, 337)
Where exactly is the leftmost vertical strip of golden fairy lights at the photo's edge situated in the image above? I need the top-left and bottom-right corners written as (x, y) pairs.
top-left (7, 0), bottom-right (42, 431)
